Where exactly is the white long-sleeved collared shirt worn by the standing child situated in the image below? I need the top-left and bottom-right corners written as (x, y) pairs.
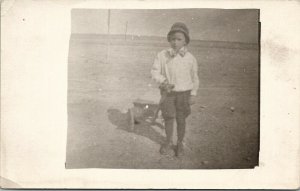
top-left (151, 47), bottom-right (199, 95)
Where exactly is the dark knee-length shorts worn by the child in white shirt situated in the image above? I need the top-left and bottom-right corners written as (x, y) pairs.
top-left (161, 91), bottom-right (191, 119)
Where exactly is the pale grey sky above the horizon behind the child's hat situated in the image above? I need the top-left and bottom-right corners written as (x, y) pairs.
top-left (72, 9), bottom-right (259, 43)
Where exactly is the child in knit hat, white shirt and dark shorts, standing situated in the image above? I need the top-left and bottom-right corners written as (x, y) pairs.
top-left (151, 22), bottom-right (199, 157)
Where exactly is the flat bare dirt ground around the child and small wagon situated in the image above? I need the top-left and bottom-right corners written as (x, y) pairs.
top-left (66, 39), bottom-right (259, 169)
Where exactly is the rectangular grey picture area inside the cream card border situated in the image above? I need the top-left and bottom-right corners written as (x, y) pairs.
top-left (65, 9), bottom-right (260, 169)
